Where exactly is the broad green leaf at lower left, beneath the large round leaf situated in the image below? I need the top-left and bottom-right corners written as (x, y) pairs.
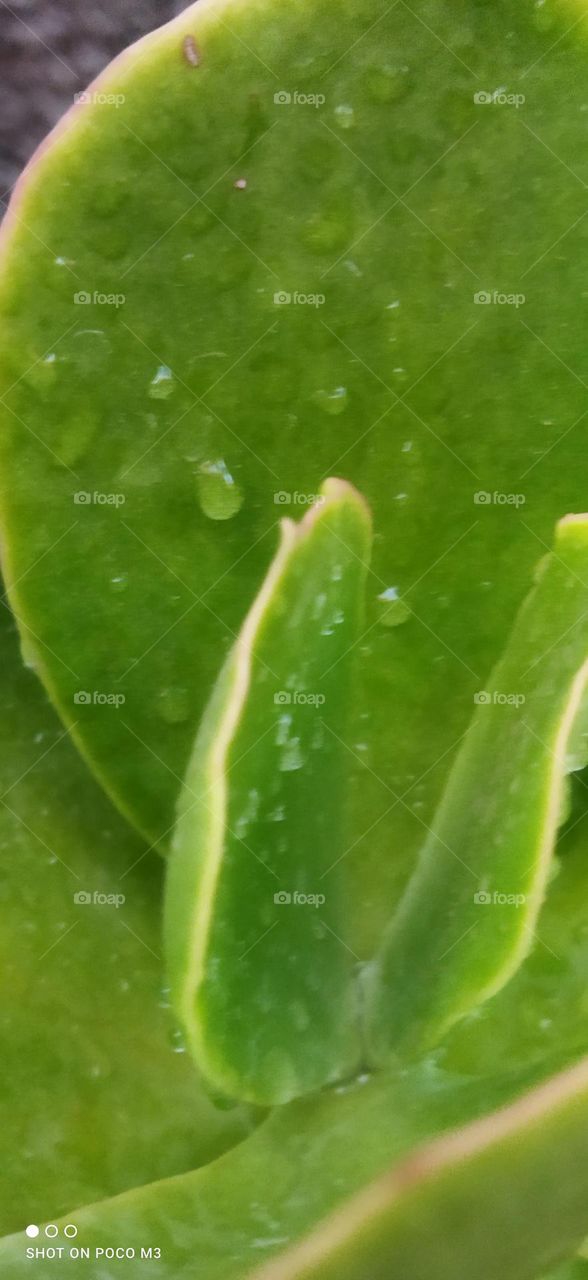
top-left (0, 608), bottom-right (252, 1228)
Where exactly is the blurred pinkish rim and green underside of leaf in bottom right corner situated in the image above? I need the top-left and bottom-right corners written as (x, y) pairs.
top-left (251, 1060), bottom-right (588, 1280)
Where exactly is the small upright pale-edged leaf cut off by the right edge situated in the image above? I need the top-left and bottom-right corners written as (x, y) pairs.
top-left (368, 516), bottom-right (588, 1059)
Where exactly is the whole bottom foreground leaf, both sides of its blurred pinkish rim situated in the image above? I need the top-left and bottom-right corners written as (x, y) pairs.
top-left (0, 1062), bottom-right (588, 1280)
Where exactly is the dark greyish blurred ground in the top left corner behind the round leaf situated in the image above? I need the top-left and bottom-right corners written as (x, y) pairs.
top-left (0, 0), bottom-right (188, 197)
